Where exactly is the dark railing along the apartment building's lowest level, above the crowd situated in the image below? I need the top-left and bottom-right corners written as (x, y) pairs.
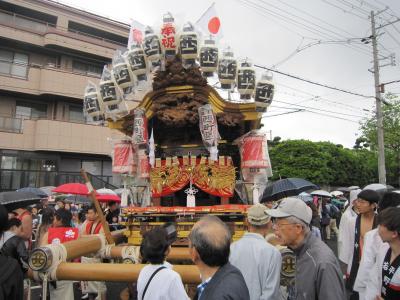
top-left (0, 169), bottom-right (117, 191)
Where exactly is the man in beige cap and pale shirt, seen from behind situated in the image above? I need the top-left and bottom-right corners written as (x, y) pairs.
top-left (229, 203), bottom-right (282, 300)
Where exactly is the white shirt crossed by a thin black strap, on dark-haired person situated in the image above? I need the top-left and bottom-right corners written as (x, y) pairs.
top-left (137, 262), bottom-right (189, 300)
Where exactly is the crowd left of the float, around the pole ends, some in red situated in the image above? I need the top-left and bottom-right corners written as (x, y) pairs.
top-left (0, 198), bottom-right (120, 300)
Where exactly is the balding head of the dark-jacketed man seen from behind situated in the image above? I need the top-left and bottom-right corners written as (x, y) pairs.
top-left (189, 216), bottom-right (231, 267)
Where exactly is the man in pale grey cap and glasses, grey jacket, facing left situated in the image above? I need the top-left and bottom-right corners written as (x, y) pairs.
top-left (266, 198), bottom-right (346, 300)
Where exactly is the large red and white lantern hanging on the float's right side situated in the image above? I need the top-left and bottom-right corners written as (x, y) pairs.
top-left (238, 130), bottom-right (272, 182)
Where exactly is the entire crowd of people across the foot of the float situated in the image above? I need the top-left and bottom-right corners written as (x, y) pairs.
top-left (0, 189), bottom-right (400, 300)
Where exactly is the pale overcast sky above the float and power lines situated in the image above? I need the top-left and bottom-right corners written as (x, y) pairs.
top-left (59, 0), bottom-right (400, 147)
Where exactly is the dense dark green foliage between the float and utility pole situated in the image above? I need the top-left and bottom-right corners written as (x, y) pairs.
top-left (270, 140), bottom-right (377, 186)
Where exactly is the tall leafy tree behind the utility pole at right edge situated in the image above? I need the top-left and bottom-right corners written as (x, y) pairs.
top-left (356, 94), bottom-right (400, 186)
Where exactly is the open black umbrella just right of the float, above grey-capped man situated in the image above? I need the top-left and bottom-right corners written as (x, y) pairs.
top-left (261, 178), bottom-right (319, 202)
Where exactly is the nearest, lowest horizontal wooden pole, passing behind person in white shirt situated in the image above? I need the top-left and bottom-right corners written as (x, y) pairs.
top-left (53, 263), bottom-right (201, 284)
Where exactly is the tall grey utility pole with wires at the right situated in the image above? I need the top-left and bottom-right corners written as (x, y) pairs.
top-left (371, 11), bottom-right (386, 184)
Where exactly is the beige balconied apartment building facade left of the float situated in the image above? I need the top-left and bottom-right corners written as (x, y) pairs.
top-left (0, 0), bottom-right (129, 190)
